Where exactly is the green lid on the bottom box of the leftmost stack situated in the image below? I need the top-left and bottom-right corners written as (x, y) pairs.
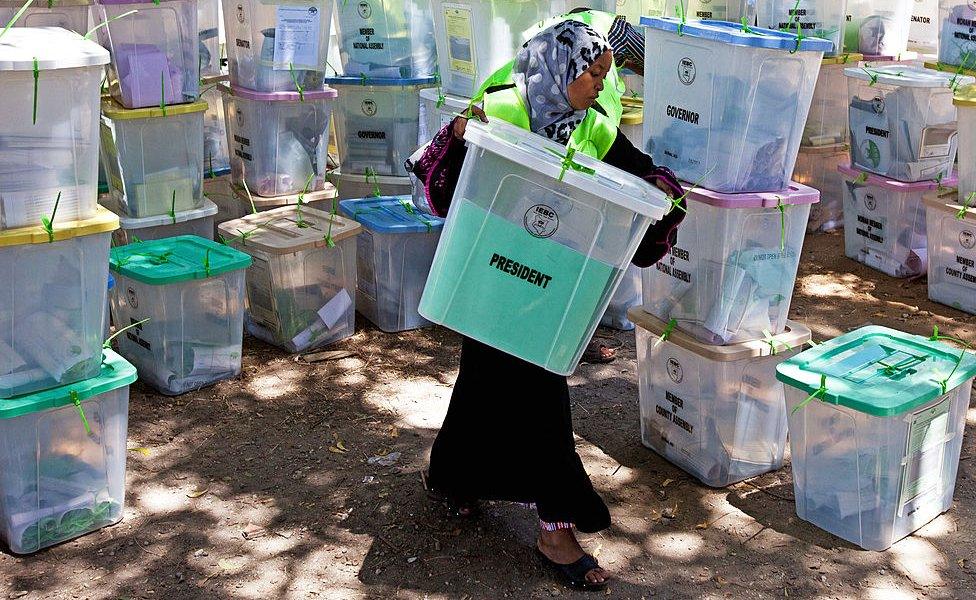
top-left (0, 350), bottom-right (136, 419)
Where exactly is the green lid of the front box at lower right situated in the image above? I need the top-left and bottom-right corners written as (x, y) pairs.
top-left (776, 326), bottom-right (976, 417)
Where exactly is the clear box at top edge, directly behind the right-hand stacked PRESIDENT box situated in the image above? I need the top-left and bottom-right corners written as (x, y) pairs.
top-left (844, 0), bottom-right (919, 56)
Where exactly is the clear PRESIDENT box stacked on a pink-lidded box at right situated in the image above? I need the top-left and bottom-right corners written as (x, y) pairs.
top-left (844, 65), bottom-right (976, 181)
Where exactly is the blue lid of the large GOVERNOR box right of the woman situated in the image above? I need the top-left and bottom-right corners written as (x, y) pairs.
top-left (641, 17), bottom-right (834, 52)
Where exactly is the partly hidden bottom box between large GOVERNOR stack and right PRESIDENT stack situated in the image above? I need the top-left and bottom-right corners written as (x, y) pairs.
top-left (793, 144), bottom-right (851, 233)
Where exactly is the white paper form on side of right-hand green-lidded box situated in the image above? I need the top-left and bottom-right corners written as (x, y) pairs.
top-left (898, 394), bottom-right (952, 510)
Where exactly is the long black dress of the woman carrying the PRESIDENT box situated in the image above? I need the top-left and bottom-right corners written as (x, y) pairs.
top-left (429, 132), bottom-right (684, 533)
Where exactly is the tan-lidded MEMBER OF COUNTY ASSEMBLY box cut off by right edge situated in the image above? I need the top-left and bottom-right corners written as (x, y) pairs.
top-left (923, 190), bottom-right (976, 315)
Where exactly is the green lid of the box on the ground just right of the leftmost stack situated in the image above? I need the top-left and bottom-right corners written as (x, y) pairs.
top-left (109, 235), bottom-right (251, 285)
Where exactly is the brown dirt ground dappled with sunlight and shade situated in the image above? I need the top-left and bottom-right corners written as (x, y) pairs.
top-left (0, 234), bottom-right (976, 600)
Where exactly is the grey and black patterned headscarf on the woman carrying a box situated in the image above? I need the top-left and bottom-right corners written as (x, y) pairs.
top-left (512, 20), bottom-right (610, 144)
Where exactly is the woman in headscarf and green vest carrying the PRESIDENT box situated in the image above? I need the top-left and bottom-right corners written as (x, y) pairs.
top-left (425, 11), bottom-right (684, 589)
